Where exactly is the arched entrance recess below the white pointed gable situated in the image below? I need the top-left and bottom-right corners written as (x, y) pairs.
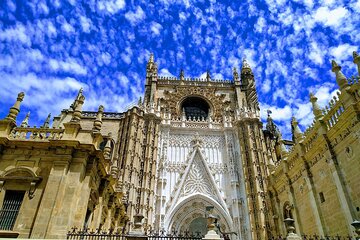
top-left (165, 193), bottom-right (233, 233)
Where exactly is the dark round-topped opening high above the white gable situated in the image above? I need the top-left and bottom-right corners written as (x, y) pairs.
top-left (181, 97), bottom-right (210, 119)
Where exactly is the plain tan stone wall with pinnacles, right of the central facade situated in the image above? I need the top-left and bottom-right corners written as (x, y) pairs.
top-left (268, 65), bottom-right (360, 236)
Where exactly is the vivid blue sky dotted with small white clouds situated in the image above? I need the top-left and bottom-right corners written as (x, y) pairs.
top-left (0, 0), bottom-right (360, 136)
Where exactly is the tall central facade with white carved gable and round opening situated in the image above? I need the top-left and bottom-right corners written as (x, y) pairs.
top-left (143, 58), bottom-right (265, 239)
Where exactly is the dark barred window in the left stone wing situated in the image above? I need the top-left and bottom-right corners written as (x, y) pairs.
top-left (0, 190), bottom-right (25, 230)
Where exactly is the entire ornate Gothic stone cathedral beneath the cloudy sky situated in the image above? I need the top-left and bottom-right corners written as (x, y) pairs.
top-left (0, 53), bottom-right (360, 240)
